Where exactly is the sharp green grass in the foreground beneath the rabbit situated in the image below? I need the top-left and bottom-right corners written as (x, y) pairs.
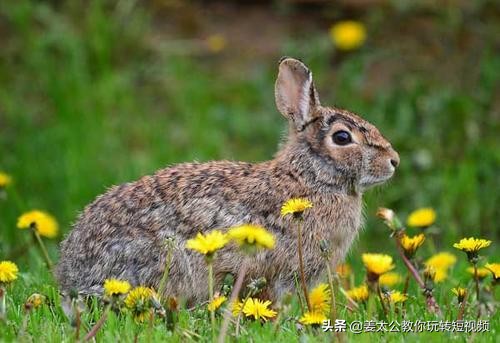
top-left (0, 262), bottom-right (500, 342)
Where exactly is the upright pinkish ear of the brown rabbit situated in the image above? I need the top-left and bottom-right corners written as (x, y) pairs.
top-left (274, 57), bottom-right (319, 131)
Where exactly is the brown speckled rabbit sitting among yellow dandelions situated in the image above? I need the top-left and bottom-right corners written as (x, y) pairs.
top-left (56, 57), bottom-right (399, 301)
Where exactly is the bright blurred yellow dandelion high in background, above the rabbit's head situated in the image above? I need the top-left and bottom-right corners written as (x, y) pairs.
top-left (330, 20), bottom-right (366, 51)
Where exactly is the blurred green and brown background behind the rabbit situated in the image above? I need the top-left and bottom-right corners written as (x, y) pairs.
top-left (0, 0), bottom-right (500, 264)
